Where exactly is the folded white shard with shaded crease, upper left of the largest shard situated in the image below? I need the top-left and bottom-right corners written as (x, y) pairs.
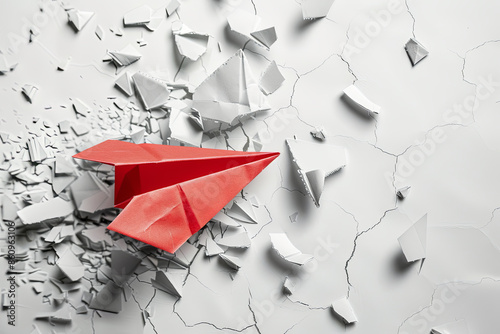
top-left (172, 21), bottom-right (210, 61)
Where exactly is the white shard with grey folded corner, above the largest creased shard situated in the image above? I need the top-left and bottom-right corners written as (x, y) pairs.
top-left (227, 9), bottom-right (278, 49)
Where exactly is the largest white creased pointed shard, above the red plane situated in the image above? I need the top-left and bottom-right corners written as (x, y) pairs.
top-left (193, 50), bottom-right (270, 124)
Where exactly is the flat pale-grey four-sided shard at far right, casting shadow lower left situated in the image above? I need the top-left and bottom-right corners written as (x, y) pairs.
top-left (398, 214), bottom-right (427, 262)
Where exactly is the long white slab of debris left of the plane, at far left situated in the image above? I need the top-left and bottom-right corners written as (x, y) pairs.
top-left (17, 197), bottom-right (75, 225)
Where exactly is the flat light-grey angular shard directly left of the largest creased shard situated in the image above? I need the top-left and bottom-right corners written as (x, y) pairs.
top-left (132, 72), bottom-right (170, 110)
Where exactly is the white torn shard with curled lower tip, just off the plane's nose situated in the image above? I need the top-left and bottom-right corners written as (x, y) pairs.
top-left (286, 139), bottom-right (347, 206)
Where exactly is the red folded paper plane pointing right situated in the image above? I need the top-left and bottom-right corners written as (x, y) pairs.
top-left (73, 140), bottom-right (279, 253)
